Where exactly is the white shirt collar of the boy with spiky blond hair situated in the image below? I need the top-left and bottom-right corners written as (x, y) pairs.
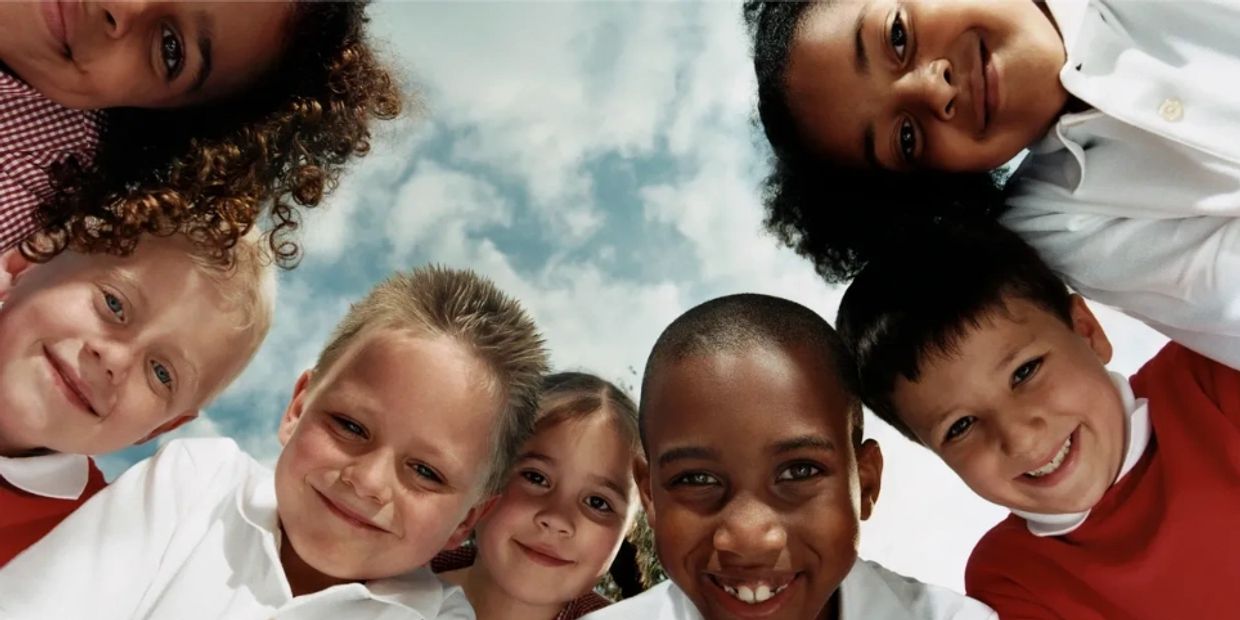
top-left (237, 466), bottom-right (464, 618)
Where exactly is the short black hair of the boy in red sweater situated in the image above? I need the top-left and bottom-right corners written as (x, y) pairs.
top-left (836, 222), bottom-right (1073, 443)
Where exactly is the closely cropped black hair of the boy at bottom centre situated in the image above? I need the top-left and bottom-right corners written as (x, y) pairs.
top-left (637, 293), bottom-right (864, 450)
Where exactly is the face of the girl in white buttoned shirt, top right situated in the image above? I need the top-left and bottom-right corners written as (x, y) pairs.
top-left (786, 0), bottom-right (1068, 171)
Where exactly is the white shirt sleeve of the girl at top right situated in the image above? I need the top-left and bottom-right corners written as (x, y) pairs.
top-left (1003, 211), bottom-right (1240, 368)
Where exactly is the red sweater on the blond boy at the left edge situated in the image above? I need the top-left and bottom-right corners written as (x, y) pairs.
top-left (0, 460), bottom-right (107, 567)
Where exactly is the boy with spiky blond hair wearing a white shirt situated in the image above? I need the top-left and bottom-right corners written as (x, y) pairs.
top-left (0, 267), bottom-right (547, 620)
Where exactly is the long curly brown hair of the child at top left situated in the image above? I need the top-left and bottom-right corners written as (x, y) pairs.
top-left (21, 1), bottom-right (403, 268)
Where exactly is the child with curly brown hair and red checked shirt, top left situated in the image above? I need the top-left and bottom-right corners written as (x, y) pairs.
top-left (0, 1), bottom-right (402, 267)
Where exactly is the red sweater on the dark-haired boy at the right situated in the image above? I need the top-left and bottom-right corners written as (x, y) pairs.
top-left (965, 342), bottom-right (1240, 620)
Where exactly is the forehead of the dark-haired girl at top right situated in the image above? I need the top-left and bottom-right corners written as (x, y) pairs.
top-left (785, 0), bottom-right (889, 167)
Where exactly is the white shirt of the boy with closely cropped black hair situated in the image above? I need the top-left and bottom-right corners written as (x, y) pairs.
top-left (584, 559), bottom-right (998, 620)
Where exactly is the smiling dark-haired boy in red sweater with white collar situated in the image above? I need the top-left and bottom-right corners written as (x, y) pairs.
top-left (838, 226), bottom-right (1240, 620)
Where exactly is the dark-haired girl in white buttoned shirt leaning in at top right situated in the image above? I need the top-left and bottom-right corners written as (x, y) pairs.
top-left (744, 0), bottom-right (1240, 367)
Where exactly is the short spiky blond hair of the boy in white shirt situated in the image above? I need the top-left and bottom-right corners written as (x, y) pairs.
top-left (311, 265), bottom-right (548, 494)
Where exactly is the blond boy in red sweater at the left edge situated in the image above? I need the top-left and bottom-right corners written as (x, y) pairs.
top-left (0, 233), bottom-right (274, 565)
